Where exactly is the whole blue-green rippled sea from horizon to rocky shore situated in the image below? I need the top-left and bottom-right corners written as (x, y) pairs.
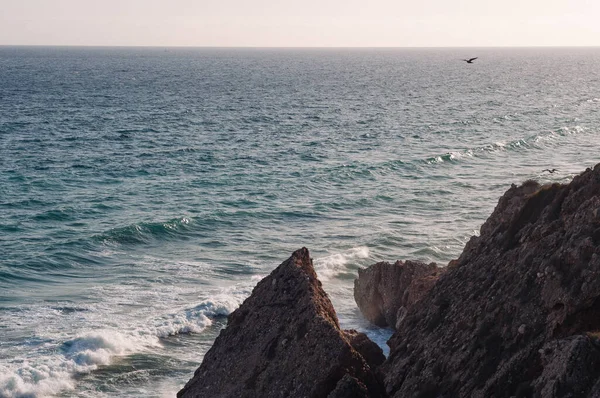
top-left (0, 47), bottom-right (600, 397)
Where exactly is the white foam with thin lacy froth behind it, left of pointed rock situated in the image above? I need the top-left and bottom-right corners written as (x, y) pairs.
top-left (0, 283), bottom-right (248, 398)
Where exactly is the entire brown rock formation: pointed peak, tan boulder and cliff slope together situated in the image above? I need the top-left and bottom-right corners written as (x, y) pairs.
top-left (178, 165), bottom-right (600, 398)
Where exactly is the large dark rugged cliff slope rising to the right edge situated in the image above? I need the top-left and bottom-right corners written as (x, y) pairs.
top-left (382, 165), bottom-right (600, 397)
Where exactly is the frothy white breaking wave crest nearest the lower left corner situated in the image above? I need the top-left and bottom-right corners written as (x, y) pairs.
top-left (0, 292), bottom-right (244, 398)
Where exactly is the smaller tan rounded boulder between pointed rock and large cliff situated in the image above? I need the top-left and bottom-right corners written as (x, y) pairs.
top-left (354, 261), bottom-right (445, 328)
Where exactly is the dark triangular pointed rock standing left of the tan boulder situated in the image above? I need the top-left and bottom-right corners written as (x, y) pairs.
top-left (177, 248), bottom-right (384, 398)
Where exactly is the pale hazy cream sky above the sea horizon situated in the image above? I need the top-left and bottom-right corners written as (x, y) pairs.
top-left (0, 0), bottom-right (600, 47)
